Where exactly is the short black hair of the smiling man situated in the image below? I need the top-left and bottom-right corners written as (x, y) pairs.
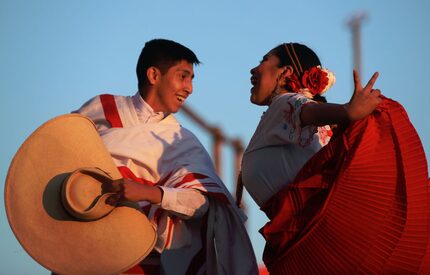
top-left (136, 39), bottom-right (200, 89)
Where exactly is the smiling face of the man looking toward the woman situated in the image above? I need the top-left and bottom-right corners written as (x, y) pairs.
top-left (152, 60), bottom-right (194, 113)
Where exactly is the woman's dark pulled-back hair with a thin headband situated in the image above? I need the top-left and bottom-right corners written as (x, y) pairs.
top-left (270, 43), bottom-right (327, 102)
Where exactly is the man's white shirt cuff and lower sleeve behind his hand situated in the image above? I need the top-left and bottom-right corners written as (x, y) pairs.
top-left (160, 186), bottom-right (209, 219)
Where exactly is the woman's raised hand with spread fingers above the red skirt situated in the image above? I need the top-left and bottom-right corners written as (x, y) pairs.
top-left (344, 70), bottom-right (382, 121)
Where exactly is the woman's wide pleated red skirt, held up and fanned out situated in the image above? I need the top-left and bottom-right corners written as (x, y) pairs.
top-left (260, 98), bottom-right (430, 274)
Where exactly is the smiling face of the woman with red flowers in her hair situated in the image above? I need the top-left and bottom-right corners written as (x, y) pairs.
top-left (251, 52), bottom-right (282, 105)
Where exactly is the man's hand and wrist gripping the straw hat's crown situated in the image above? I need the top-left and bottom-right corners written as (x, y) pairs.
top-left (103, 179), bottom-right (163, 204)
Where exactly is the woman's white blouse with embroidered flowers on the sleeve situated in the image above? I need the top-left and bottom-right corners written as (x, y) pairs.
top-left (242, 93), bottom-right (331, 206)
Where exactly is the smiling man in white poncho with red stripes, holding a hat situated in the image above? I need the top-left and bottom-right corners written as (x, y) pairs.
top-left (76, 39), bottom-right (258, 274)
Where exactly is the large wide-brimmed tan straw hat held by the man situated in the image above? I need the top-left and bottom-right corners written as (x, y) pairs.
top-left (5, 114), bottom-right (156, 274)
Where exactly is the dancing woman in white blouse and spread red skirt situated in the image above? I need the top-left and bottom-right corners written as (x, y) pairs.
top-left (241, 43), bottom-right (429, 274)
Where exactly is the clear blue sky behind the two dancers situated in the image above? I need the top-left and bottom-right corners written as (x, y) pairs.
top-left (0, 0), bottom-right (430, 274)
